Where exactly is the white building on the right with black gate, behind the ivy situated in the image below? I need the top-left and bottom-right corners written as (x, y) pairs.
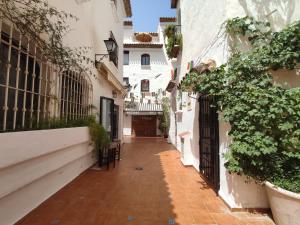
top-left (169, 0), bottom-right (300, 210)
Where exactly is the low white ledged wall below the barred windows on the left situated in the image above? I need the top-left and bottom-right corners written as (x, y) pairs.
top-left (0, 127), bottom-right (94, 225)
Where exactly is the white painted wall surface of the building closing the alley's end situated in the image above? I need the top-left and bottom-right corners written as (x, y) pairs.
top-left (123, 23), bottom-right (172, 135)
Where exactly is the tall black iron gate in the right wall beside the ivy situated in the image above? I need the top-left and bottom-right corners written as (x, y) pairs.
top-left (199, 96), bottom-right (220, 193)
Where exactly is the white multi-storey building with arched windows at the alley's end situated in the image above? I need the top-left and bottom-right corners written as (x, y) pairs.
top-left (123, 17), bottom-right (175, 136)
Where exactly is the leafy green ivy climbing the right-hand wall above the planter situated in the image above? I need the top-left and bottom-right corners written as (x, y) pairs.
top-left (181, 17), bottom-right (300, 193)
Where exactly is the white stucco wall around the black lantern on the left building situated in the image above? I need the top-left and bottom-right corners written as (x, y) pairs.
top-left (49, 0), bottom-right (125, 139)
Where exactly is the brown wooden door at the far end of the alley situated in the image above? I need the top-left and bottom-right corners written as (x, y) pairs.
top-left (132, 116), bottom-right (157, 137)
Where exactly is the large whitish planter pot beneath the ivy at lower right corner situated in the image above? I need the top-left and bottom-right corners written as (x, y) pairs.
top-left (265, 182), bottom-right (300, 225)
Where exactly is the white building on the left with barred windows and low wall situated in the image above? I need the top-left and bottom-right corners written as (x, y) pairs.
top-left (0, 0), bottom-right (131, 225)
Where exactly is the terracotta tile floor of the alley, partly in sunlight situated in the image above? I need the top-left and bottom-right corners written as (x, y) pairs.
top-left (17, 138), bottom-right (274, 225)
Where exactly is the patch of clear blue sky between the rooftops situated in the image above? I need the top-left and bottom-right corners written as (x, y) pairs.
top-left (131, 0), bottom-right (176, 32)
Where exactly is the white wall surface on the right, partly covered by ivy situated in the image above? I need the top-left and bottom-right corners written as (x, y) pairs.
top-left (170, 0), bottom-right (300, 208)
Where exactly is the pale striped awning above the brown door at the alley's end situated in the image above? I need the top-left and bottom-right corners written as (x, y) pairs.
top-left (124, 102), bottom-right (162, 115)
